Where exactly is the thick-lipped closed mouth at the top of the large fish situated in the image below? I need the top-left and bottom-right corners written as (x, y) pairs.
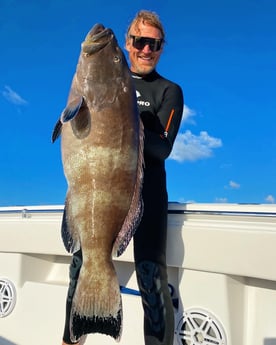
top-left (81, 24), bottom-right (114, 55)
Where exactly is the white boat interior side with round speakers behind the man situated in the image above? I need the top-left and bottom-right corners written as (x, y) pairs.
top-left (0, 202), bottom-right (276, 345)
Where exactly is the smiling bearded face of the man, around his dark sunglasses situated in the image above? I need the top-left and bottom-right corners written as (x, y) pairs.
top-left (126, 22), bottom-right (163, 75)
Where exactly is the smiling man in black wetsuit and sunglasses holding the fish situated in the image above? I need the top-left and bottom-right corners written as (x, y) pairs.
top-left (126, 11), bottom-right (183, 345)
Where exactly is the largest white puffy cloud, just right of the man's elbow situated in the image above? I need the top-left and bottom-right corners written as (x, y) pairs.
top-left (169, 130), bottom-right (222, 162)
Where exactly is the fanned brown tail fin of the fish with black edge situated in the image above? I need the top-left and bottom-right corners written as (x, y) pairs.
top-left (70, 262), bottom-right (123, 341)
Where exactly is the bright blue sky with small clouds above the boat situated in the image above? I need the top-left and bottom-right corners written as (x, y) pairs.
top-left (0, 0), bottom-right (276, 206)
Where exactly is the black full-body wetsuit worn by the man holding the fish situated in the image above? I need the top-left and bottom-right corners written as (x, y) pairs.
top-left (63, 71), bottom-right (183, 345)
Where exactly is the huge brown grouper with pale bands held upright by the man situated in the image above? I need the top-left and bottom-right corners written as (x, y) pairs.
top-left (52, 24), bottom-right (146, 341)
